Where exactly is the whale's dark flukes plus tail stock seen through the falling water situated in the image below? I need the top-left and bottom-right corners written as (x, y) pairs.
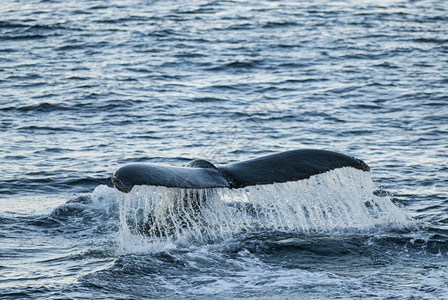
top-left (112, 150), bottom-right (370, 237)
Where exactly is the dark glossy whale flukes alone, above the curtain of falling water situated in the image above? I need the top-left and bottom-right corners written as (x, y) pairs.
top-left (112, 149), bottom-right (370, 193)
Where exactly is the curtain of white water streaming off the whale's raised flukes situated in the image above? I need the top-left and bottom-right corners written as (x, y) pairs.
top-left (116, 168), bottom-right (410, 251)
